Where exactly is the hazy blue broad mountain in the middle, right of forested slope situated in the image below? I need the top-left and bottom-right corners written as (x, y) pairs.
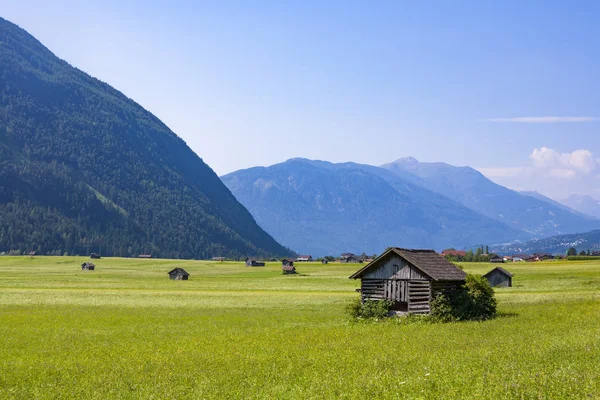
top-left (221, 159), bottom-right (524, 255)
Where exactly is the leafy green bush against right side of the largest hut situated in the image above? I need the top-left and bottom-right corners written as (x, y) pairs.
top-left (431, 274), bottom-right (497, 322)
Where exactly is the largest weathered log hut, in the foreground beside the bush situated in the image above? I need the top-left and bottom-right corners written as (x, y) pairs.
top-left (350, 247), bottom-right (467, 314)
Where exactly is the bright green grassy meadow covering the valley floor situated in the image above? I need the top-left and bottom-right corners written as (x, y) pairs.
top-left (0, 257), bottom-right (600, 399)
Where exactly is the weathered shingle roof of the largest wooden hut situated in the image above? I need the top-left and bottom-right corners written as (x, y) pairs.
top-left (350, 247), bottom-right (467, 281)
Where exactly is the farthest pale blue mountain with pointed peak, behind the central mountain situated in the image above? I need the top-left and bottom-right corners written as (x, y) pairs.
top-left (381, 157), bottom-right (600, 238)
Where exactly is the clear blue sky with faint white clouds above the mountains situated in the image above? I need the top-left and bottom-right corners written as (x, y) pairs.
top-left (0, 0), bottom-right (600, 198)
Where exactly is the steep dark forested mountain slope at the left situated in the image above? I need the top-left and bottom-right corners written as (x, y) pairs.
top-left (0, 18), bottom-right (290, 258)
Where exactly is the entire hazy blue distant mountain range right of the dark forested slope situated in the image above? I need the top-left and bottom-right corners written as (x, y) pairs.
top-left (221, 157), bottom-right (600, 255)
